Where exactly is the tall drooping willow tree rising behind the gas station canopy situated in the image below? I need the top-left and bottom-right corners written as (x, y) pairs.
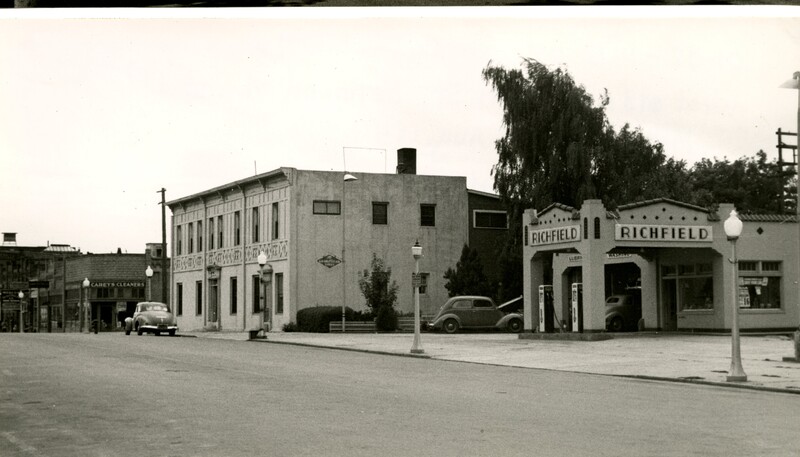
top-left (482, 58), bottom-right (676, 297)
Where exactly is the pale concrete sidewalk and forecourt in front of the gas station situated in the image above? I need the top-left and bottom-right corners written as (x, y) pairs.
top-left (184, 332), bottom-right (800, 394)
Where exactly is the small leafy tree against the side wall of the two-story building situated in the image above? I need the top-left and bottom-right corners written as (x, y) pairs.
top-left (358, 253), bottom-right (397, 330)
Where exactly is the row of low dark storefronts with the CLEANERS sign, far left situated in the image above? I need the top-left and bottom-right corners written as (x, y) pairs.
top-left (0, 234), bottom-right (169, 332)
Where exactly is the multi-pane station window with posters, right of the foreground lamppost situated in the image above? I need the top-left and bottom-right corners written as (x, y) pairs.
top-left (739, 261), bottom-right (781, 309)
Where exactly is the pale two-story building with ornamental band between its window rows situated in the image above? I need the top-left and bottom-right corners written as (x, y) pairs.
top-left (168, 149), bottom-right (510, 330)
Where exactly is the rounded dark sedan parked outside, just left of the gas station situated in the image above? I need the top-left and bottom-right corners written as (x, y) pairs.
top-left (428, 295), bottom-right (523, 333)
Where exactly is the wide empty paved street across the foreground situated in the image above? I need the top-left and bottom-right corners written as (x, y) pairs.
top-left (0, 333), bottom-right (800, 456)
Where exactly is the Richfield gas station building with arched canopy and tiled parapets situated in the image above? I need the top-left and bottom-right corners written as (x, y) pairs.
top-left (523, 198), bottom-right (800, 333)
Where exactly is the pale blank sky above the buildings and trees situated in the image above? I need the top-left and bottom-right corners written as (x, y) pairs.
top-left (0, 6), bottom-right (800, 253)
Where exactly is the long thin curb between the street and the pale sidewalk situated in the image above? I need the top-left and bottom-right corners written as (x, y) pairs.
top-left (246, 339), bottom-right (800, 395)
